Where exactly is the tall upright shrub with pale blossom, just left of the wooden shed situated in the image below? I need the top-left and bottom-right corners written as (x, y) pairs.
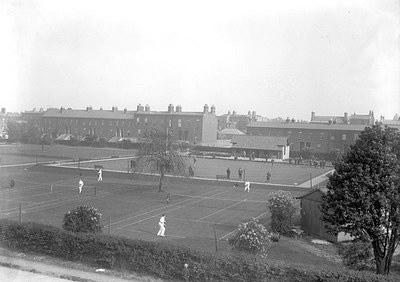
top-left (268, 191), bottom-right (296, 234)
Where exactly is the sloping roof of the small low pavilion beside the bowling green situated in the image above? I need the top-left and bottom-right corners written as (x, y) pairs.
top-left (231, 135), bottom-right (288, 151)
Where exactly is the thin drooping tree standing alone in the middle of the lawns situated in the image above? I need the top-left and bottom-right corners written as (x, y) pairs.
top-left (134, 132), bottom-right (188, 192)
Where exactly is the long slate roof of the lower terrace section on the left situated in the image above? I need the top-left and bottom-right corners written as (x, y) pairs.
top-left (43, 109), bottom-right (134, 119)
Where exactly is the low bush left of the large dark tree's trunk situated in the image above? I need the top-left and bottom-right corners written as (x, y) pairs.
top-left (338, 241), bottom-right (375, 270)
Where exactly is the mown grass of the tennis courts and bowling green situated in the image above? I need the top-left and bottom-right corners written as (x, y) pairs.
top-left (0, 144), bottom-right (338, 264)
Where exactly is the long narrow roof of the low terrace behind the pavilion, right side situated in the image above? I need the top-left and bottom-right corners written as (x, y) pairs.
top-left (247, 121), bottom-right (367, 131)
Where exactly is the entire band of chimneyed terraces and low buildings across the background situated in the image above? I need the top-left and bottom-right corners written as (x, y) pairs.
top-left (3, 104), bottom-right (400, 159)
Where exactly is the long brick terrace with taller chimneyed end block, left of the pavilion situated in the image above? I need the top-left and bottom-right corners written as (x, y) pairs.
top-left (39, 104), bottom-right (217, 144)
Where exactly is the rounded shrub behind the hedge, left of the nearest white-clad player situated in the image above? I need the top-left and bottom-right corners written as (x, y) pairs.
top-left (63, 205), bottom-right (101, 233)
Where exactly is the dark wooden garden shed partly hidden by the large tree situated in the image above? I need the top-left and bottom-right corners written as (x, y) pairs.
top-left (297, 187), bottom-right (352, 243)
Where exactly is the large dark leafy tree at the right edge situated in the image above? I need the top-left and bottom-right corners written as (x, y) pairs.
top-left (321, 125), bottom-right (400, 274)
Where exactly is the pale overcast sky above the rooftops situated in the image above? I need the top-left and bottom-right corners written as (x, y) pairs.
top-left (0, 0), bottom-right (400, 120)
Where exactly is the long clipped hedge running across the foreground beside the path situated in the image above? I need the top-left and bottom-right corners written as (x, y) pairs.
top-left (0, 219), bottom-right (395, 282)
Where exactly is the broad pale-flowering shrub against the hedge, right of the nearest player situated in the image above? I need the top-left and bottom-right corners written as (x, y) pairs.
top-left (229, 218), bottom-right (271, 256)
